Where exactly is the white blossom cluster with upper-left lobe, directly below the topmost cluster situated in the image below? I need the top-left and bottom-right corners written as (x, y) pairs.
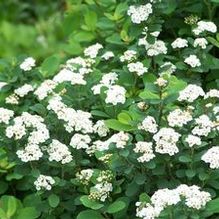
top-left (138, 38), bottom-right (167, 56)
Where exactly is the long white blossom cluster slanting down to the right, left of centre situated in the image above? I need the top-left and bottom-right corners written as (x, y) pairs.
top-left (47, 95), bottom-right (93, 133)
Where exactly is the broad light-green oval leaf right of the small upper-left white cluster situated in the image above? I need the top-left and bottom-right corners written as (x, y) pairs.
top-left (40, 55), bottom-right (60, 77)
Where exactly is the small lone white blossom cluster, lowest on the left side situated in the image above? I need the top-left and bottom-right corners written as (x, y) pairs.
top-left (34, 174), bottom-right (55, 190)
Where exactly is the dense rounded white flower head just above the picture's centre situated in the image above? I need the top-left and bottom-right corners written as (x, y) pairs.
top-left (105, 85), bottom-right (126, 105)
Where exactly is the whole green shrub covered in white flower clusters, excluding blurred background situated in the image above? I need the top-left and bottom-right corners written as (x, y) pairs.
top-left (0, 0), bottom-right (219, 219)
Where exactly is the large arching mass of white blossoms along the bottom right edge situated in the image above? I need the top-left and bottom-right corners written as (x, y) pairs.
top-left (136, 184), bottom-right (211, 219)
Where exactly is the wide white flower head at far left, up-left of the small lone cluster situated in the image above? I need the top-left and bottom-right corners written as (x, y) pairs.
top-left (16, 144), bottom-right (43, 162)
